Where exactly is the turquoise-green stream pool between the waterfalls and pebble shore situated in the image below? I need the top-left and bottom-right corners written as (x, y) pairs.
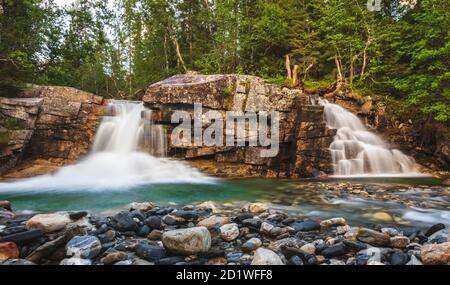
top-left (0, 177), bottom-right (450, 228)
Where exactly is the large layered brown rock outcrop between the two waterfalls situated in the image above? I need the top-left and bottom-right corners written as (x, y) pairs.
top-left (143, 75), bottom-right (335, 177)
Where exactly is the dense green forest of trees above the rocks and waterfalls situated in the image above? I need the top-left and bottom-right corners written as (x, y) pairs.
top-left (0, 0), bottom-right (450, 123)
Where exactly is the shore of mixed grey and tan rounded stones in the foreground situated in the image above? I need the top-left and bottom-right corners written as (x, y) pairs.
top-left (0, 203), bottom-right (450, 265)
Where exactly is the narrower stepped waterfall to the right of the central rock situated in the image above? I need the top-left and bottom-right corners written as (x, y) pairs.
top-left (319, 99), bottom-right (418, 176)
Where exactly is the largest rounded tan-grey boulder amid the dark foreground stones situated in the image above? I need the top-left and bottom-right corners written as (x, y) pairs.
top-left (162, 227), bottom-right (211, 255)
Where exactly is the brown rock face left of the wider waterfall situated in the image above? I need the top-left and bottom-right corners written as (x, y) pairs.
top-left (0, 86), bottom-right (103, 173)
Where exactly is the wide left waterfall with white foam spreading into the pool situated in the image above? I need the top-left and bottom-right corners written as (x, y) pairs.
top-left (0, 101), bottom-right (213, 191)
